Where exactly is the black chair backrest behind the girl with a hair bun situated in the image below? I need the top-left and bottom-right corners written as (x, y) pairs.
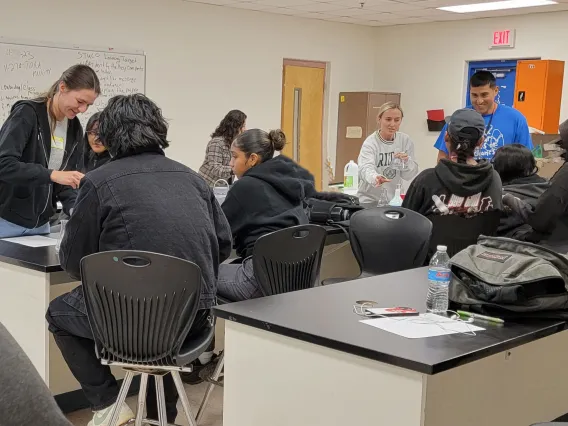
top-left (252, 225), bottom-right (327, 296)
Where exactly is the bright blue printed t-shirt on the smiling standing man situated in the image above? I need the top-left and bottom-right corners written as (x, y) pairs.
top-left (434, 105), bottom-right (533, 160)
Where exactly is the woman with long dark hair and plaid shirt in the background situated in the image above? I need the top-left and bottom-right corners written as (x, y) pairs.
top-left (199, 109), bottom-right (247, 186)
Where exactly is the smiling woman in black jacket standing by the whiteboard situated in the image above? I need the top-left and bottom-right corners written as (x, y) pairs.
top-left (0, 65), bottom-right (100, 238)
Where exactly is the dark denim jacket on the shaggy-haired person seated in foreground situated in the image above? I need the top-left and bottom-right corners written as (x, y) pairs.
top-left (60, 150), bottom-right (231, 313)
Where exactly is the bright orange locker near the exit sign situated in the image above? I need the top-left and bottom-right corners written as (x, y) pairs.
top-left (514, 60), bottom-right (564, 134)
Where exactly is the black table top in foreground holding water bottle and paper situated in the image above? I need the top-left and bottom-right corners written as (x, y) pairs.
top-left (215, 268), bottom-right (566, 374)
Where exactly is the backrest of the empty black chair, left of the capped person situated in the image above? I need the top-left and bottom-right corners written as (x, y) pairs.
top-left (349, 206), bottom-right (432, 275)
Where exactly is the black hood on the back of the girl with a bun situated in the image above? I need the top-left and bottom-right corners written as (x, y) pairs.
top-left (243, 155), bottom-right (316, 204)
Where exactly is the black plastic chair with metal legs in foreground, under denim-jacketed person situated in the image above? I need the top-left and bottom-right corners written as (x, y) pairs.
top-left (81, 251), bottom-right (215, 426)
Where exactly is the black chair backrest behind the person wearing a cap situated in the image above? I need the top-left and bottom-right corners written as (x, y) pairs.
top-left (428, 210), bottom-right (501, 259)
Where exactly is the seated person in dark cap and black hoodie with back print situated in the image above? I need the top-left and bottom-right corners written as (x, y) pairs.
top-left (402, 109), bottom-right (503, 217)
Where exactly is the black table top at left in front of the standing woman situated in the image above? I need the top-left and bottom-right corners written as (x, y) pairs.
top-left (0, 235), bottom-right (63, 272)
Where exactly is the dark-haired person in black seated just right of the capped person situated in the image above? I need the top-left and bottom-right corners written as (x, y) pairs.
top-left (493, 144), bottom-right (550, 238)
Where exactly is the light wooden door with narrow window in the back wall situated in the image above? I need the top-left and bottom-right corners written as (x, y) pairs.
top-left (282, 60), bottom-right (325, 190)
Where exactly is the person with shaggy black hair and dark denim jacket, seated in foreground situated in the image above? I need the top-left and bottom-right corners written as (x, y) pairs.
top-left (47, 94), bottom-right (231, 426)
